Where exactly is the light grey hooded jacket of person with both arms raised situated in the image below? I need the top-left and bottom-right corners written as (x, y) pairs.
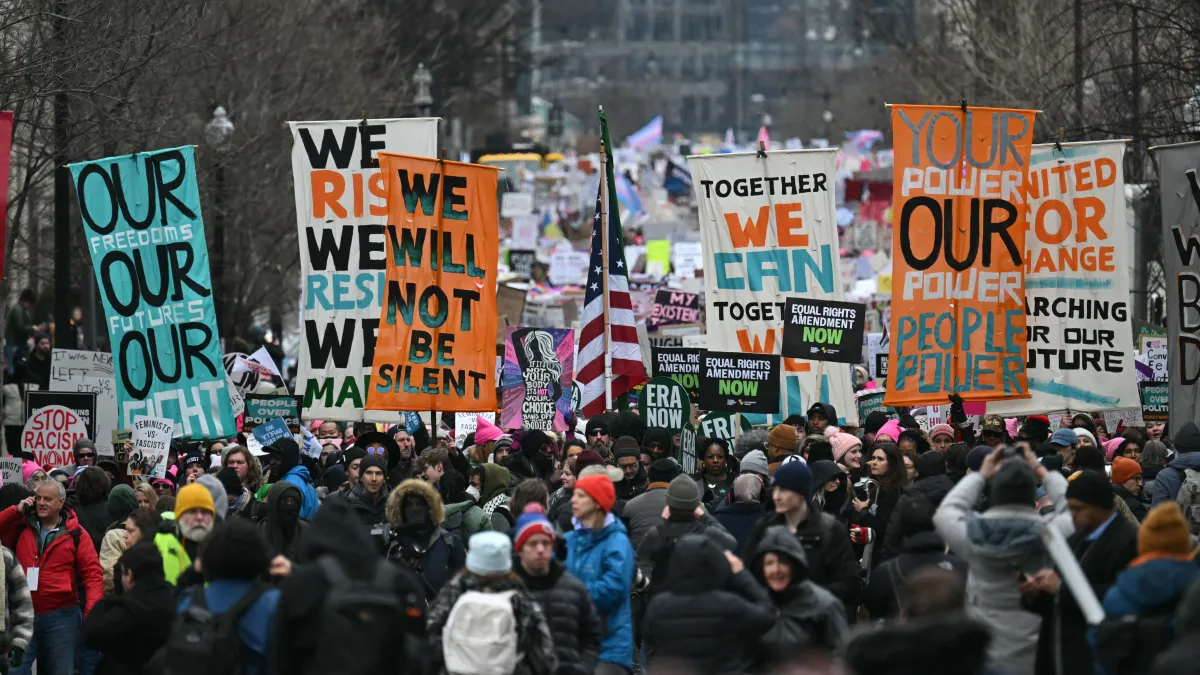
top-left (934, 472), bottom-right (1073, 674)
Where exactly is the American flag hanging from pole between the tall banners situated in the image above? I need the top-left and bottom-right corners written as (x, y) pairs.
top-left (575, 181), bottom-right (646, 417)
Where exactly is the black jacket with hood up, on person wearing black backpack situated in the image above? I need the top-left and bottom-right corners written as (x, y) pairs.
top-left (274, 502), bottom-right (425, 675)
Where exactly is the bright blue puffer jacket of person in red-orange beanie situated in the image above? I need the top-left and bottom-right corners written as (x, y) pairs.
top-left (566, 513), bottom-right (636, 670)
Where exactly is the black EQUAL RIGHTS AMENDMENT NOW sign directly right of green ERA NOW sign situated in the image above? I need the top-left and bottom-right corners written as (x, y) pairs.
top-left (700, 352), bottom-right (780, 414)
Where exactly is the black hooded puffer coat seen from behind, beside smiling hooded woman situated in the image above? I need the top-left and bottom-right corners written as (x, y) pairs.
top-left (642, 534), bottom-right (775, 675)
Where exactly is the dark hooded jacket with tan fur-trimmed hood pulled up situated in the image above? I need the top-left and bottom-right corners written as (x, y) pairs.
top-left (388, 478), bottom-right (467, 598)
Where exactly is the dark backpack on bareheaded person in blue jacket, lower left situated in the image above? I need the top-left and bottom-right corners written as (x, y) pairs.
top-left (163, 584), bottom-right (266, 675)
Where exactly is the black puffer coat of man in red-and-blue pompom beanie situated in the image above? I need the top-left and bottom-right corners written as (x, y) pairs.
top-left (512, 558), bottom-right (604, 675)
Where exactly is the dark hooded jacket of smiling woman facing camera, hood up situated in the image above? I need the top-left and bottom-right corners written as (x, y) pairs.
top-left (750, 526), bottom-right (850, 665)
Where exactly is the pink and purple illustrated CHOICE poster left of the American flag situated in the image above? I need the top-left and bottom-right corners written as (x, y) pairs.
top-left (500, 328), bottom-right (575, 431)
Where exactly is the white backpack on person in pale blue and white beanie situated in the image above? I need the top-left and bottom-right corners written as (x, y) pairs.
top-left (442, 591), bottom-right (521, 675)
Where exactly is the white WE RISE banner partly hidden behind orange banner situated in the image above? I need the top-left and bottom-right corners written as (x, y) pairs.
top-left (290, 119), bottom-right (439, 422)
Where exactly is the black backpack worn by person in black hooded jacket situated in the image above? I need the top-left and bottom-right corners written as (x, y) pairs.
top-left (312, 555), bottom-right (416, 675)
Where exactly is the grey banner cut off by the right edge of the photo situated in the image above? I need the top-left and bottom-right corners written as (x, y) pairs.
top-left (1154, 143), bottom-right (1200, 419)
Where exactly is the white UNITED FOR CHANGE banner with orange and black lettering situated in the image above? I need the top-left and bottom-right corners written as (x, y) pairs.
top-left (988, 141), bottom-right (1137, 417)
